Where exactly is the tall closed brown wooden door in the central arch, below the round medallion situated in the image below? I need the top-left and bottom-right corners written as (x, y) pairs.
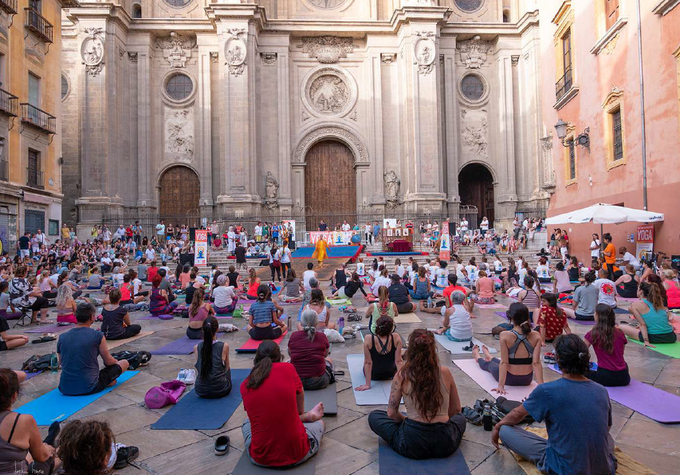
top-left (305, 140), bottom-right (357, 231)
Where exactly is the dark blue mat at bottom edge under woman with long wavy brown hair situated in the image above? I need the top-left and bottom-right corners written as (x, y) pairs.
top-left (378, 439), bottom-right (470, 475)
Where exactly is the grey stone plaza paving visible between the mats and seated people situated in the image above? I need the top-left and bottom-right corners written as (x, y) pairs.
top-left (5, 261), bottom-right (680, 475)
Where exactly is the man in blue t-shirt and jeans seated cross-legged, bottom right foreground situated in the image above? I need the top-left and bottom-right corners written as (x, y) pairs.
top-left (492, 334), bottom-right (617, 475)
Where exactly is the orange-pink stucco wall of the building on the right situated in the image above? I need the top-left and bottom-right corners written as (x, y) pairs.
top-left (540, 0), bottom-right (680, 262)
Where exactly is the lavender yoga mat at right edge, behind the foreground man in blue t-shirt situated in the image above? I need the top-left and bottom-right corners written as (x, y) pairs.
top-left (548, 365), bottom-right (680, 424)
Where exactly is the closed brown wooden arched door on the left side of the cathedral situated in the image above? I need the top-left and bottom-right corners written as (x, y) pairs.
top-left (158, 166), bottom-right (201, 226)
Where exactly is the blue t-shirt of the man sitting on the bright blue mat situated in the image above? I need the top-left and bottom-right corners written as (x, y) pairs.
top-left (57, 327), bottom-right (104, 396)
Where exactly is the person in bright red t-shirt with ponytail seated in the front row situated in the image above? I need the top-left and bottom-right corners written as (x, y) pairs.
top-left (241, 340), bottom-right (325, 468)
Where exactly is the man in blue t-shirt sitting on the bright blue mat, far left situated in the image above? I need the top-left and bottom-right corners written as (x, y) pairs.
top-left (57, 303), bottom-right (133, 396)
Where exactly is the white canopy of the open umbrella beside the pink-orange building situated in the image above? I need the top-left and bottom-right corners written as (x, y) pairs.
top-left (545, 203), bottom-right (664, 225)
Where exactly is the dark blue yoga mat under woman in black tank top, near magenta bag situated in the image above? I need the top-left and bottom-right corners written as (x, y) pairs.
top-left (151, 369), bottom-right (250, 430)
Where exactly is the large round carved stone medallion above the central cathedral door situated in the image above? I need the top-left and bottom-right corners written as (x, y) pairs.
top-left (302, 66), bottom-right (356, 116)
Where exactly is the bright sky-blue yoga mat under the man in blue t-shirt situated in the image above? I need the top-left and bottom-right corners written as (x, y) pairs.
top-left (15, 371), bottom-right (139, 426)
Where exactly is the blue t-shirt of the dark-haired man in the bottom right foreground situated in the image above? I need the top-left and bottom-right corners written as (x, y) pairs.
top-left (524, 378), bottom-right (615, 475)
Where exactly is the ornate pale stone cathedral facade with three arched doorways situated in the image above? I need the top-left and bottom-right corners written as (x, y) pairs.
top-left (62, 0), bottom-right (553, 229)
